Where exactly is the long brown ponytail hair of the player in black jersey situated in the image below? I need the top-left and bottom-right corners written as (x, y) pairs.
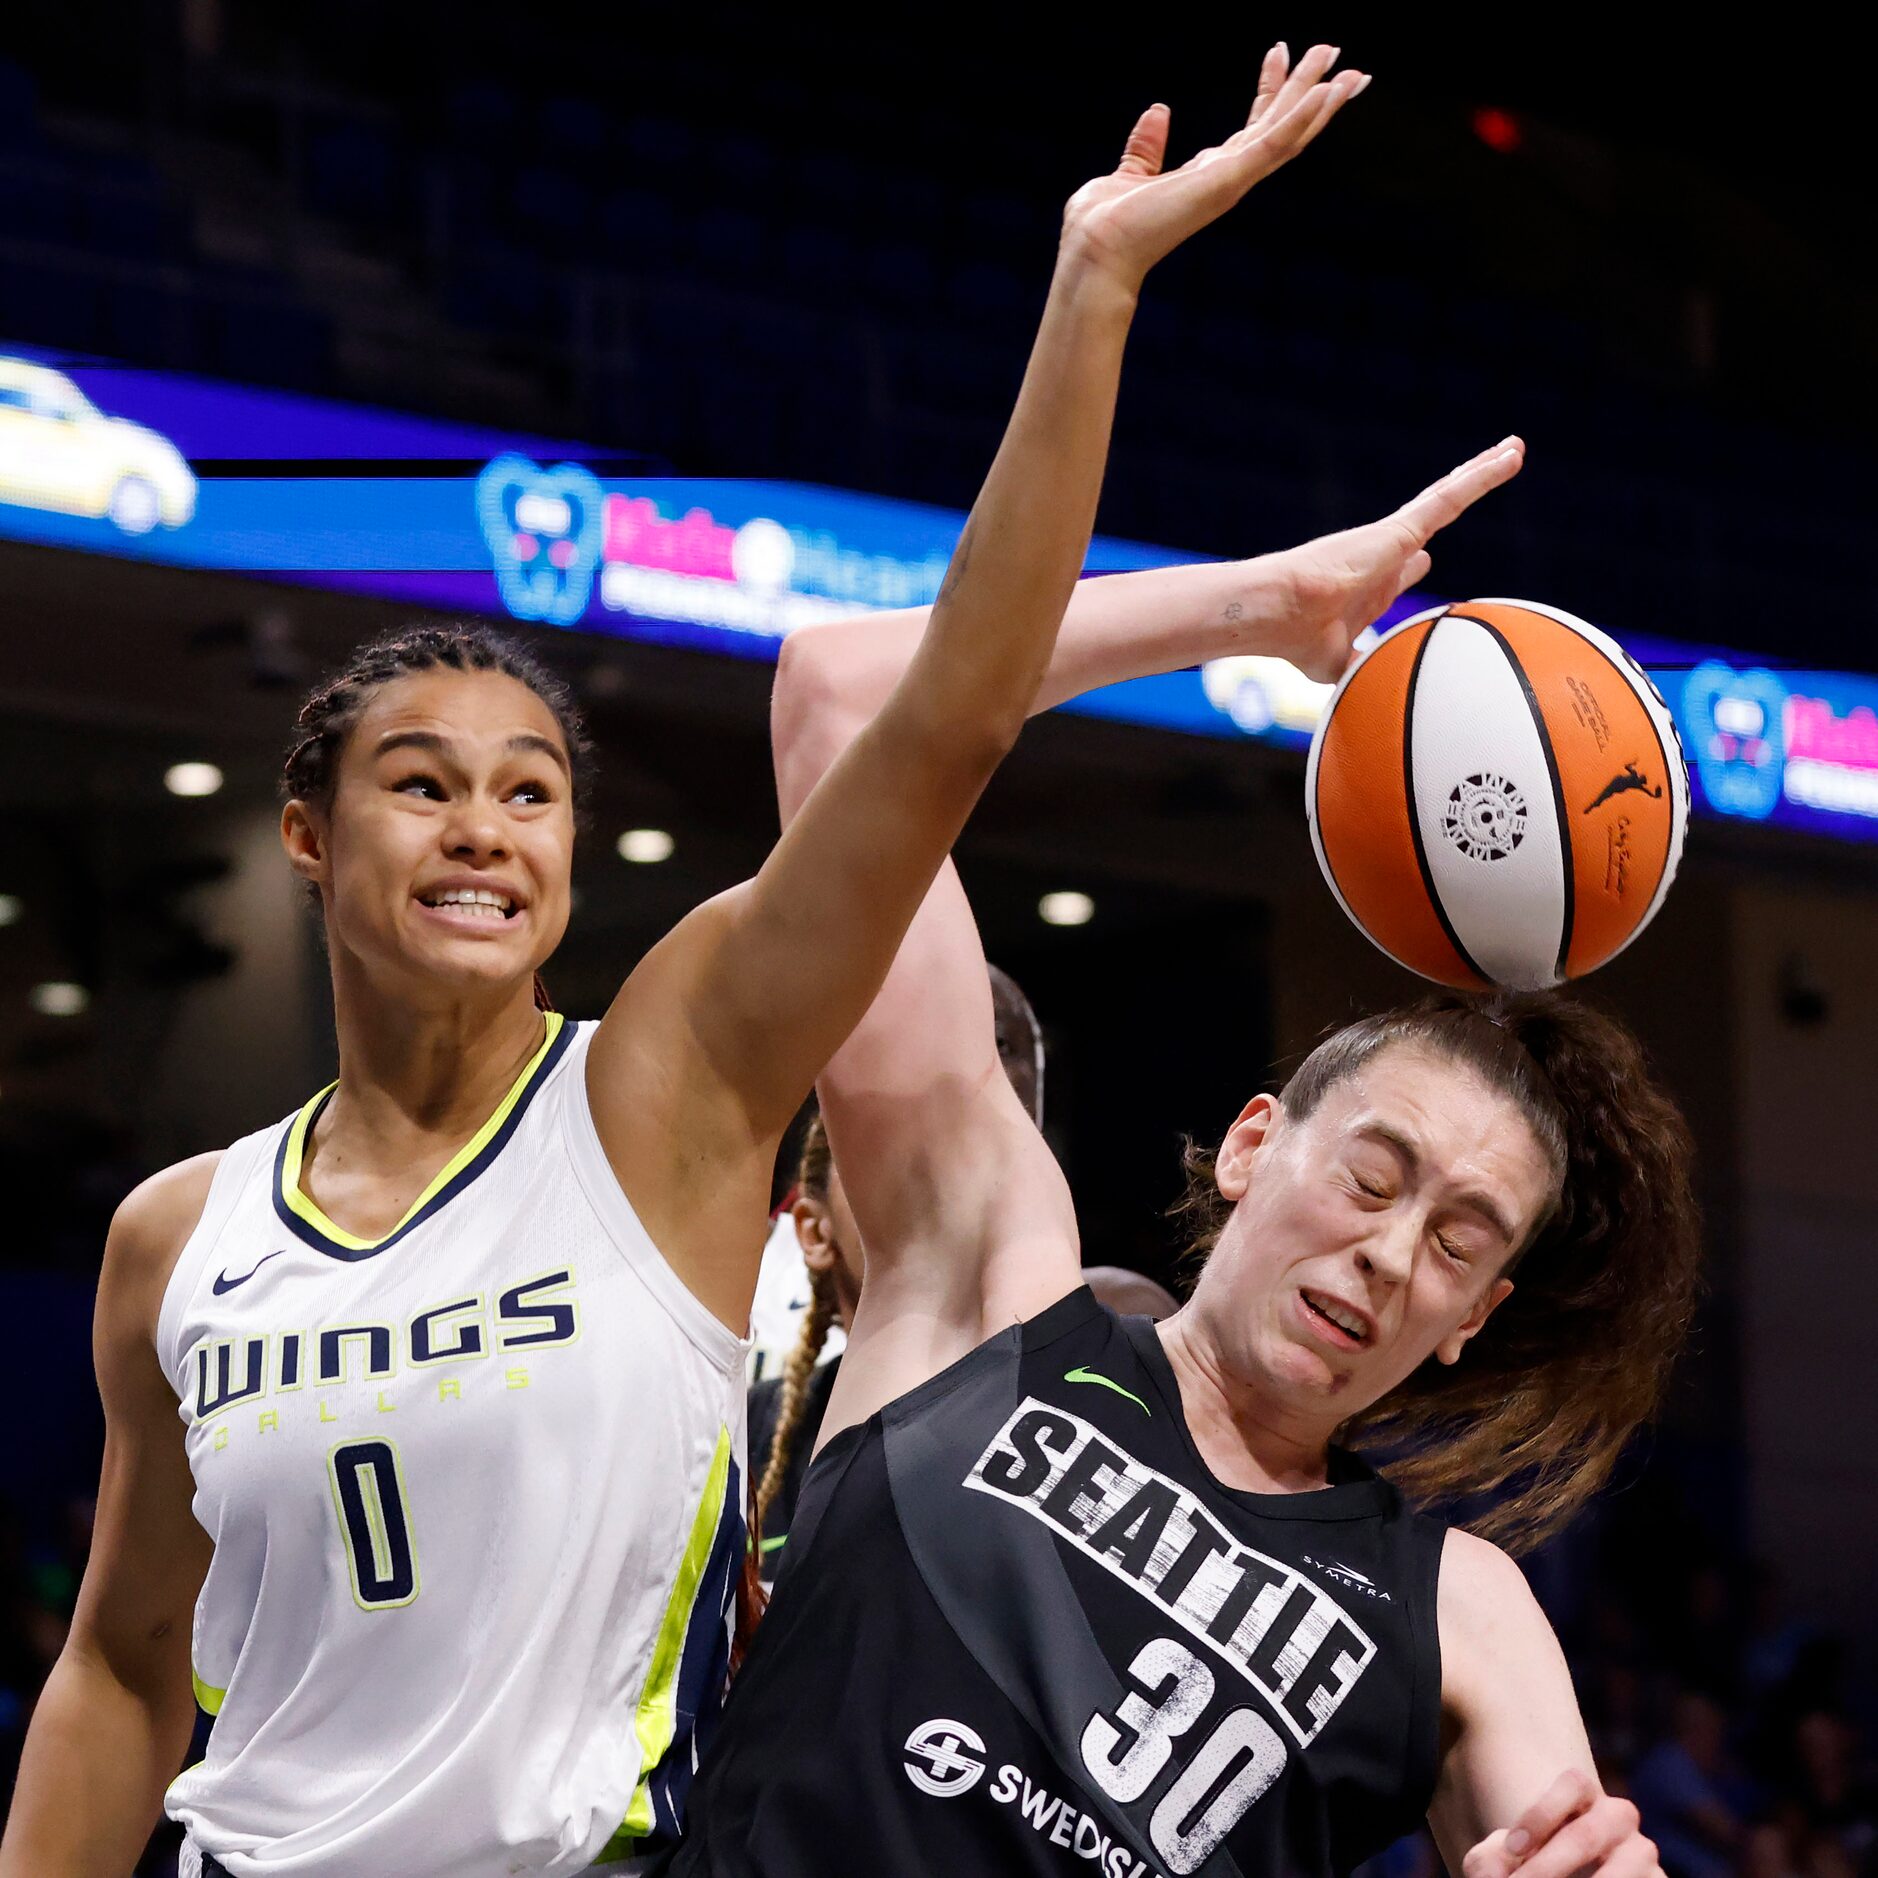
top-left (1174, 992), bottom-right (1701, 1551)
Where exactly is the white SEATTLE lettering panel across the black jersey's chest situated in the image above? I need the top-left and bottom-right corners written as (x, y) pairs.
top-left (963, 1397), bottom-right (1377, 1745)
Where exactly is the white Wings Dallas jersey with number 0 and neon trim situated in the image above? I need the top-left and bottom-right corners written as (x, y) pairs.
top-left (158, 1016), bottom-right (746, 1878)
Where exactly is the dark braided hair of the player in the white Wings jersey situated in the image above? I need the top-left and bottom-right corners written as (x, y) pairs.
top-left (280, 620), bottom-right (593, 1010)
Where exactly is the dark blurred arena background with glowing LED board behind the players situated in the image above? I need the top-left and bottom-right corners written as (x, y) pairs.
top-left (0, 11), bottom-right (1878, 1878)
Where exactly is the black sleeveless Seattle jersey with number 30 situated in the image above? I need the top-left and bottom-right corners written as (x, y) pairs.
top-left (667, 1290), bottom-right (1442, 1878)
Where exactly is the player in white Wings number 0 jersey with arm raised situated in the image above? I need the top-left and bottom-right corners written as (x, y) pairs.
top-left (0, 47), bottom-right (1365, 1878)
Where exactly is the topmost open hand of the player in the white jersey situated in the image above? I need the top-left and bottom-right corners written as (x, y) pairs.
top-left (1063, 45), bottom-right (1369, 293)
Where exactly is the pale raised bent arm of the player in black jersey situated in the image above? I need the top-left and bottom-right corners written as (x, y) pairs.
top-left (770, 439), bottom-right (1521, 1440)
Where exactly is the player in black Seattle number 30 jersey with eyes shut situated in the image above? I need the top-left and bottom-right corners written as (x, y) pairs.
top-left (669, 66), bottom-right (1698, 1878)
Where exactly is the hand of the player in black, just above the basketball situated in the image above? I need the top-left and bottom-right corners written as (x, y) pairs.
top-left (1273, 438), bottom-right (1525, 684)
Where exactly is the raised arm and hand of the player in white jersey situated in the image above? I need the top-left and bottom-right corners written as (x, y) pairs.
top-left (588, 47), bottom-right (1363, 1326)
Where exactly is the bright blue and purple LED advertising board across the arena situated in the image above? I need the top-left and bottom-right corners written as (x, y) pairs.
top-left (0, 346), bottom-right (1878, 839)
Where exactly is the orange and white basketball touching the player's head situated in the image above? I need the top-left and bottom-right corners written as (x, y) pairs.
top-left (1305, 599), bottom-right (1688, 990)
